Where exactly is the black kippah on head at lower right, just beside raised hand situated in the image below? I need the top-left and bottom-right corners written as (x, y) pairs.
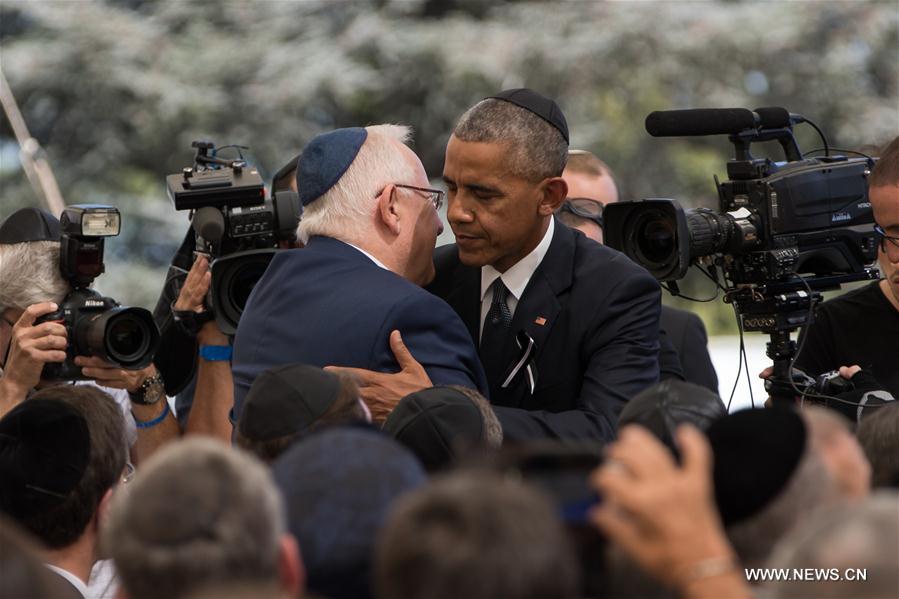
top-left (707, 408), bottom-right (807, 526)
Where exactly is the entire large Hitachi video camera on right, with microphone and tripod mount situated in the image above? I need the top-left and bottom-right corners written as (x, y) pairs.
top-left (603, 108), bottom-right (878, 404)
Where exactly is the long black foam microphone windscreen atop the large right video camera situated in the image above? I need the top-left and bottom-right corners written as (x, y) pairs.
top-left (646, 108), bottom-right (757, 137)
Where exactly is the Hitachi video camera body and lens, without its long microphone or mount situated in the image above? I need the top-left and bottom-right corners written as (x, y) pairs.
top-left (603, 120), bottom-right (877, 285)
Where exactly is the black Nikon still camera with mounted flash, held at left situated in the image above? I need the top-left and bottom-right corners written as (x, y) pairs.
top-left (36, 204), bottom-right (159, 381)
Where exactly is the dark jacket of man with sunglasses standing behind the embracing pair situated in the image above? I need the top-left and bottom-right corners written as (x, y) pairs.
top-left (661, 306), bottom-right (718, 393)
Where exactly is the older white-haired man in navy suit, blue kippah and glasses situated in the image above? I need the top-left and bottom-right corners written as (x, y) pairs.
top-left (232, 125), bottom-right (487, 421)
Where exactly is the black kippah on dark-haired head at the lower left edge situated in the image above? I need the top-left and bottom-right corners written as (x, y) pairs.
top-left (0, 399), bottom-right (90, 520)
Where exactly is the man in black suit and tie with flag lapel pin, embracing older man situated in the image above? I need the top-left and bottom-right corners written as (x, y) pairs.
top-left (429, 89), bottom-right (659, 439)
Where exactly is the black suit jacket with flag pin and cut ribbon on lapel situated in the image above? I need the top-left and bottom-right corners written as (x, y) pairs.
top-left (428, 220), bottom-right (660, 441)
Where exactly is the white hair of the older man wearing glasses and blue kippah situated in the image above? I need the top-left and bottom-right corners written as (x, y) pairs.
top-left (297, 125), bottom-right (415, 243)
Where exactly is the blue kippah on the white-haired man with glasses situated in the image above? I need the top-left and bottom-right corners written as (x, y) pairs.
top-left (297, 127), bottom-right (368, 206)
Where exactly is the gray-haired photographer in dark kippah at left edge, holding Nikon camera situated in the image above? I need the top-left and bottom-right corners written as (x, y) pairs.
top-left (0, 208), bottom-right (179, 461)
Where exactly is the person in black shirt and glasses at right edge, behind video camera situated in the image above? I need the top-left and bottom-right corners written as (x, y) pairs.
top-left (796, 137), bottom-right (899, 397)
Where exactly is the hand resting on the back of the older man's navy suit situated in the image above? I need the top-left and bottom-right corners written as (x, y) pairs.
top-left (325, 331), bottom-right (433, 424)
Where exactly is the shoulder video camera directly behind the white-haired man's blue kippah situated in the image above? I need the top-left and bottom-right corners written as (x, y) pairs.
top-left (166, 141), bottom-right (301, 335)
